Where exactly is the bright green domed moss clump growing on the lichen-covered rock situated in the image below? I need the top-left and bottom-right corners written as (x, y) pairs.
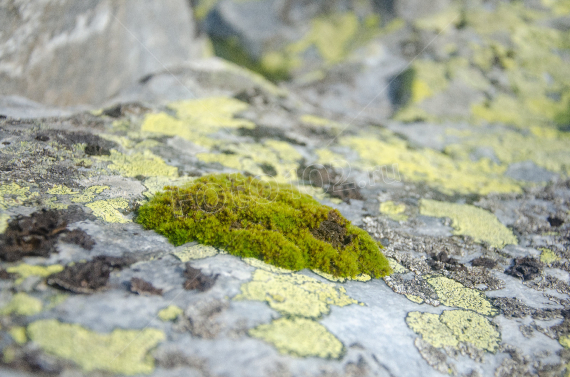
top-left (137, 174), bottom-right (392, 277)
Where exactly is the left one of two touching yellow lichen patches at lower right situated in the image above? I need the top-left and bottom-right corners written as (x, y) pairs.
top-left (406, 312), bottom-right (459, 348)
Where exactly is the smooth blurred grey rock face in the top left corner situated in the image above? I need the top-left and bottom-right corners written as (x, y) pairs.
top-left (0, 0), bottom-right (200, 106)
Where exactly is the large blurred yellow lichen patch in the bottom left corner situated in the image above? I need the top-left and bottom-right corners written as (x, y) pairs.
top-left (28, 319), bottom-right (165, 375)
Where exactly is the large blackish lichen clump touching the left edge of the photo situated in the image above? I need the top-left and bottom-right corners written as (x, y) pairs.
top-left (0, 210), bottom-right (67, 262)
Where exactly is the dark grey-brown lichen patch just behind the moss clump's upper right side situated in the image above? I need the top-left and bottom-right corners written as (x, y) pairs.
top-left (297, 160), bottom-right (364, 204)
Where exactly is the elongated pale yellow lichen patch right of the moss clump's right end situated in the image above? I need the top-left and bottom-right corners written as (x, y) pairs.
top-left (420, 199), bottom-right (518, 248)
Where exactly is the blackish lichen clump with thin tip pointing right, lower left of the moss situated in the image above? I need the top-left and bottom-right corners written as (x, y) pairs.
top-left (47, 256), bottom-right (135, 293)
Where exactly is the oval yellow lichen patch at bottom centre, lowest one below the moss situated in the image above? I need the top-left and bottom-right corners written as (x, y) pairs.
top-left (249, 318), bottom-right (343, 359)
